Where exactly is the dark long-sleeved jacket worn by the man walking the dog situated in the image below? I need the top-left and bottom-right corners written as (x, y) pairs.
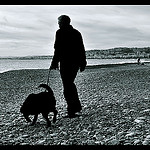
top-left (52, 25), bottom-right (86, 68)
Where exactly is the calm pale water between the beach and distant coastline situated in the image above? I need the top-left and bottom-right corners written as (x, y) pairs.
top-left (0, 59), bottom-right (150, 73)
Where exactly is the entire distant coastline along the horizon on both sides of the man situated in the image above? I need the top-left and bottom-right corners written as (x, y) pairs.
top-left (0, 47), bottom-right (150, 60)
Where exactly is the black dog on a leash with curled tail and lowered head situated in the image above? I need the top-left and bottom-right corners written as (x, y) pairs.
top-left (20, 84), bottom-right (57, 126)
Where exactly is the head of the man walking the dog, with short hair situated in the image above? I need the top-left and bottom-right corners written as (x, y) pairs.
top-left (58, 15), bottom-right (71, 28)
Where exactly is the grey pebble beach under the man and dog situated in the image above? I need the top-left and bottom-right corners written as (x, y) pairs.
top-left (0, 64), bottom-right (150, 145)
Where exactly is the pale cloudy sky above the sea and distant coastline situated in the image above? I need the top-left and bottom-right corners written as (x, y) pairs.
top-left (0, 5), bottom-right (150, 57)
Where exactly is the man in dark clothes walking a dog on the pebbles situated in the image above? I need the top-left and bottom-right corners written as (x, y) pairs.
top-left (50, 15), bottom-right (87, 118)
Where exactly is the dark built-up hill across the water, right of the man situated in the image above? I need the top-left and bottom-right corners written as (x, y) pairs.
top-left (86, 47), bottom-right (150, 59)
